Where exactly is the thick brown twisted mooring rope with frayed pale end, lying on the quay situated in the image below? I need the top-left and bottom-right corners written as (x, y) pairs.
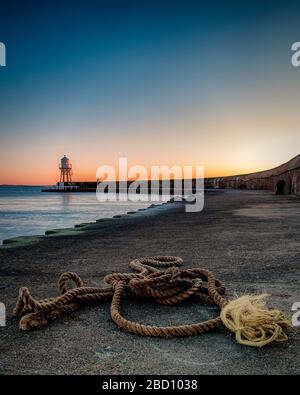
top-left (14, 256), bottom-right (290, 347)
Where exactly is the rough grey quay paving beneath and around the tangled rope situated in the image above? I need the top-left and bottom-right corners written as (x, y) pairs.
top-left (0, 191), bottom-right (300, 374)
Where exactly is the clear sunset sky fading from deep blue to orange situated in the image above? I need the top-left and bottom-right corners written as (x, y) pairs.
top-left (0, 0), bottom-right (300, 185)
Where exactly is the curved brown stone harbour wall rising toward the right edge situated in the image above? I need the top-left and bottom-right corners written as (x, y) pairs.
top-left (205, 155), bottom-right (300, 195)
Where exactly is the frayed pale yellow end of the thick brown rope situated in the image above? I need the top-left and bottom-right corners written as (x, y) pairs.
top-left (221, 294), bottom-right (292, 347)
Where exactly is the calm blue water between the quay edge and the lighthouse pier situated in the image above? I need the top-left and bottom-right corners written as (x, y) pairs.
top-left (0, 186), bottom-right (154, 244)
